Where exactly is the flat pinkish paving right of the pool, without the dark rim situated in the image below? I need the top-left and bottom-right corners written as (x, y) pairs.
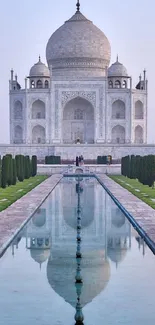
top-left (97, 174), bottom-right (155, 243)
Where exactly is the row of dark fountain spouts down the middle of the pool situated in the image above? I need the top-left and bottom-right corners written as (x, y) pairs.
top-left (75, 180), bottom-right (84, 325)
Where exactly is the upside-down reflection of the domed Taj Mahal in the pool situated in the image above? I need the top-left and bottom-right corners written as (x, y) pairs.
top-left (11, 178), bottom-right (144, 307)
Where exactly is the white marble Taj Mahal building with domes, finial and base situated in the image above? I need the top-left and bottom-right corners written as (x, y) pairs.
top-left (5, 1), bottom-right (154, 158)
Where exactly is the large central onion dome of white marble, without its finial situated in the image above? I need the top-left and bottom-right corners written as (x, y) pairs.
top-left (46, 11), bottom-right (111, 76)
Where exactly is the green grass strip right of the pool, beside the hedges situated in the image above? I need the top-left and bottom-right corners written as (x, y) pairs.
top-left (109, 175), bottom-right (155, 209)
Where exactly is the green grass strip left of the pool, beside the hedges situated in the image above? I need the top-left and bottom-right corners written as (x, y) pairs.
top-left (0, 175), bottom-right (47, 211)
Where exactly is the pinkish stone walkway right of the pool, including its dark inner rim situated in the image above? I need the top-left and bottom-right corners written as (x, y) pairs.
top-left (94, 174), bottom-right (155, 255)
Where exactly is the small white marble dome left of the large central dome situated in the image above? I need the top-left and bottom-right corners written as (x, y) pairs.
top-left (30, 56), bottom-right (50, 78)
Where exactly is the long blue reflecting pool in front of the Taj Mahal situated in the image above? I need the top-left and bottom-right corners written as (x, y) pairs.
top-left (0, 177), bottom-right (155, 325)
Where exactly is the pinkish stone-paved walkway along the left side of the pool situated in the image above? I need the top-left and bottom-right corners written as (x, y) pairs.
top-left (0, 174), bottom-right (62, 255)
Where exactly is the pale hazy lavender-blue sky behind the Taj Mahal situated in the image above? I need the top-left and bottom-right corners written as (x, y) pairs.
top-left (0, 0), bottom-right (155, 143)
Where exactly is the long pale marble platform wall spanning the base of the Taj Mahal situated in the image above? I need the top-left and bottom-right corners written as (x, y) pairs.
top-left (0, 144), bottom-right (155, 160)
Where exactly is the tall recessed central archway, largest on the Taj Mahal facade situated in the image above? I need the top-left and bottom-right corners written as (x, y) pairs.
top-left (62, 97), bottom-right (94, 143)
